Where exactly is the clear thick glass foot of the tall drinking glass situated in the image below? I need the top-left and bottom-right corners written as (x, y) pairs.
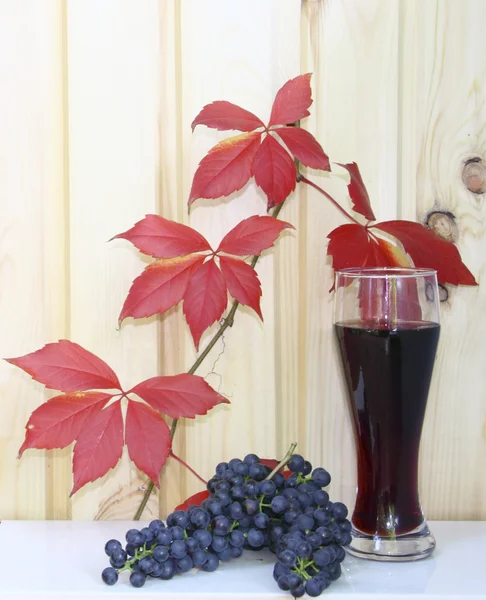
top-left (346, 523), bottom-right (435, 562)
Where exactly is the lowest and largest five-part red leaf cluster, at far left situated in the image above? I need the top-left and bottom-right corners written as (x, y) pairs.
top-left (7, 340), bottom-right (228, 495)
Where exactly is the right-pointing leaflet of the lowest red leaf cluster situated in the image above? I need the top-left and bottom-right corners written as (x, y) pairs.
top-left (128, 373), bottom-right (229, 419)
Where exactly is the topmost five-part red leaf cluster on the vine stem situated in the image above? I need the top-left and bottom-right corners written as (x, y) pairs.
top-left (189, 74), bottom-right (330, 208)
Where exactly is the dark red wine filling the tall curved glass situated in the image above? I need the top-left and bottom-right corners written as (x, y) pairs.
top-left (334, 322), bottom-right (440, 536)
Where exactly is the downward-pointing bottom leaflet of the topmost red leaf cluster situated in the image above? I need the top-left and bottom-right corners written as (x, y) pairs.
top-left (253, 135), bottom-right (297, 208)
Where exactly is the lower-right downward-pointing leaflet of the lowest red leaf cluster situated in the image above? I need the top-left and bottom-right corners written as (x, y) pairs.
top-left (125, 400), bottom-right (171, 487)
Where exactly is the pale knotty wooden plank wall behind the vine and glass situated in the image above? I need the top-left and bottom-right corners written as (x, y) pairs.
top-left (0, 0), bottom-right (486, 519)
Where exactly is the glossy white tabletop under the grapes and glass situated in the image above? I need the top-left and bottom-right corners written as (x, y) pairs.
top-left (0, 521), bottom-right (486, 600)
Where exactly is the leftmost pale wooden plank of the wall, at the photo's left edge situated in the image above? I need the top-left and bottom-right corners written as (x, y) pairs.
top-left (0, 0), bottom-right (69, 519)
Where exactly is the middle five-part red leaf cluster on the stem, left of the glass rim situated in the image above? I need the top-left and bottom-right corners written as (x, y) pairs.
top-left (116, 215), bottom-right (292, 349)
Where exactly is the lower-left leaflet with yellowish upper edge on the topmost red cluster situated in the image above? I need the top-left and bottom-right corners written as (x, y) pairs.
top-left (189, 133), bottom-right (261, 206)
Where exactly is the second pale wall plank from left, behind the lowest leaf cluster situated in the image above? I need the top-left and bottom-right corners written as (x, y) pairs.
top-left (67, 0), bottom-right (160, 519)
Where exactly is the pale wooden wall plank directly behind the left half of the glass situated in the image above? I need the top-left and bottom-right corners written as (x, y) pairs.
top-left (300, 0), bottom-right (398, 506)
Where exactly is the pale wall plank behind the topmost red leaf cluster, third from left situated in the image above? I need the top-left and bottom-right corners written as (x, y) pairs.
top-left (174, 0), bottom-right (300, 508)
